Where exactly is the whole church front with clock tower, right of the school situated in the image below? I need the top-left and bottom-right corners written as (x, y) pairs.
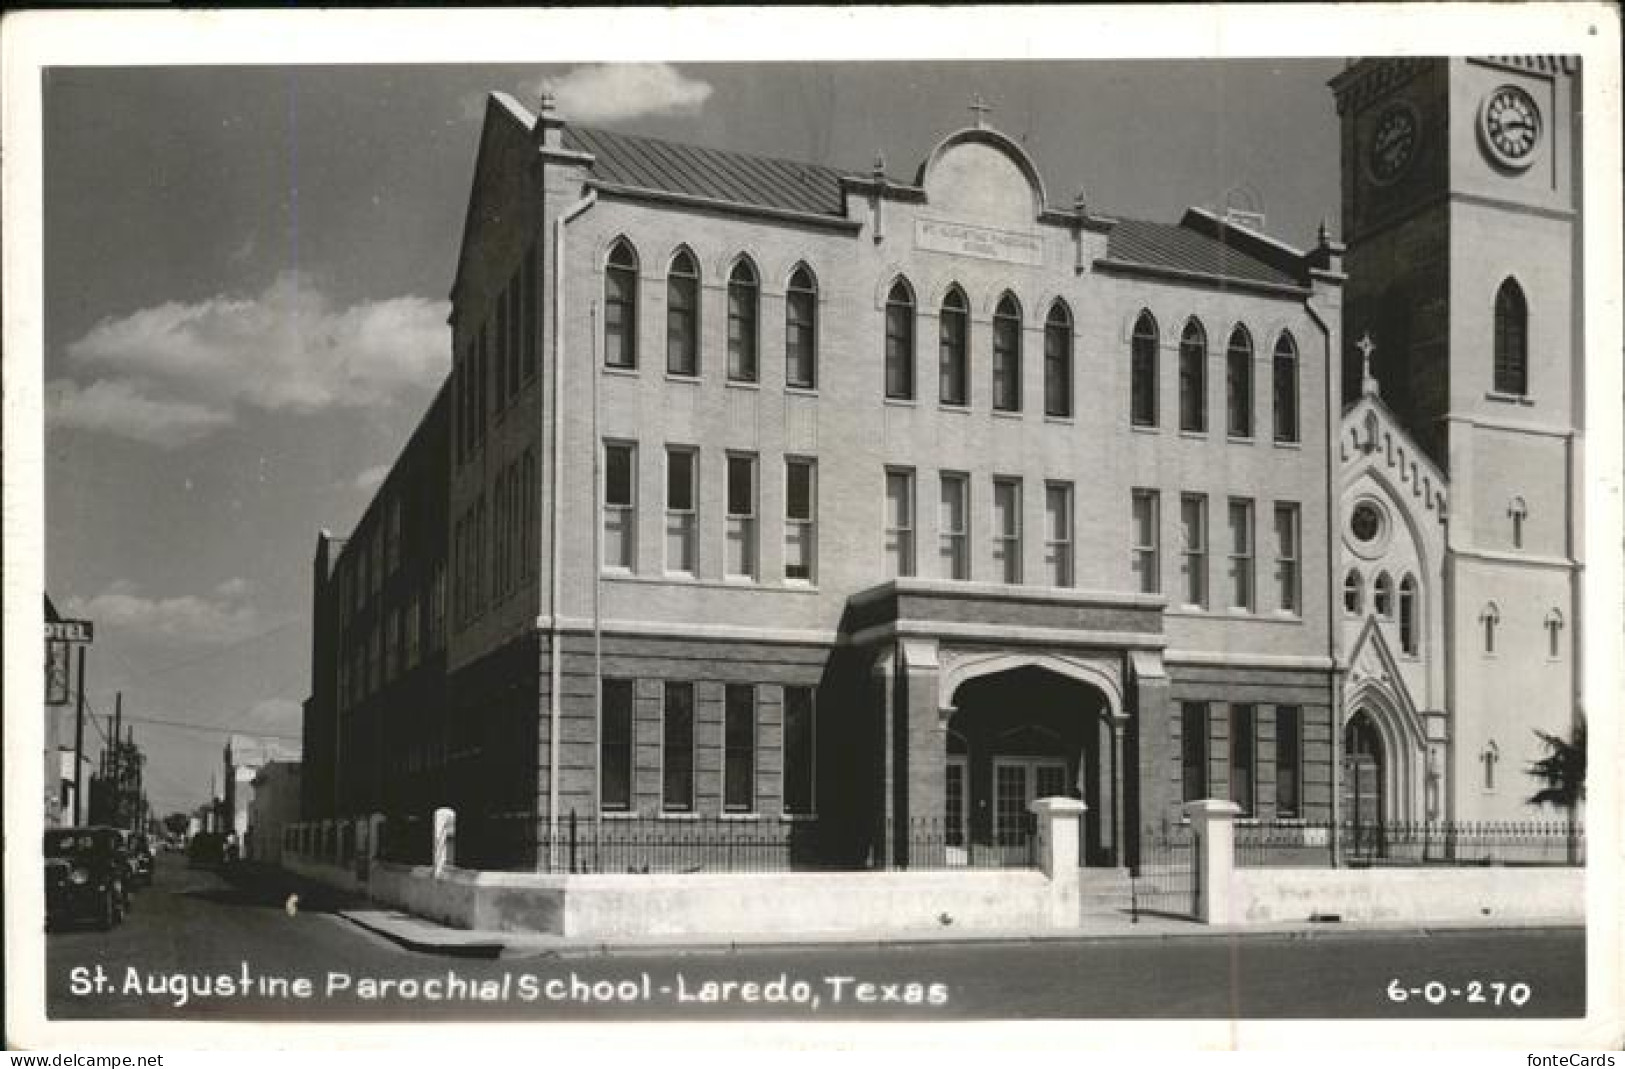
top-left (1333, 57), bottom-right (1584, 820)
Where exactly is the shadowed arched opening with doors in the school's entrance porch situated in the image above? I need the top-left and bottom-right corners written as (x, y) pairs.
top-left (944, 661), bottom-right (1121, 864)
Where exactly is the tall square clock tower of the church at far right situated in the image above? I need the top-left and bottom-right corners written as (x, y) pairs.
top-left (1331, 57), bottom-right (1584, 819)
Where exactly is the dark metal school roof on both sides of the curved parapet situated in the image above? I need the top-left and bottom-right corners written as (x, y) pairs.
top-left (564, 125), bottom-right (1302, 288)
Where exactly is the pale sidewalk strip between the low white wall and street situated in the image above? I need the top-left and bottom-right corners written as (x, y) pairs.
top-left (336, 908), bottom-right (1581, 959)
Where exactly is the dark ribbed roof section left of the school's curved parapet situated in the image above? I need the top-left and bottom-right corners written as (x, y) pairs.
top-left (564, 125), bottom-right (845, 218)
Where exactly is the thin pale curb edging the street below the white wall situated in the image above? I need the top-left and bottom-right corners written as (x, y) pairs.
top-left (338, 910), bottom-right (1586, 959)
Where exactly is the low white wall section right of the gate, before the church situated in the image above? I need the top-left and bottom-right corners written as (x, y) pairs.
top-left (1235, 866), bottom-right (1586, 924)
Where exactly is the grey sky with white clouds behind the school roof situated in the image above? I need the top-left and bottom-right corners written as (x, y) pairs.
top-left (42, 58), bottom-right (1342, 814)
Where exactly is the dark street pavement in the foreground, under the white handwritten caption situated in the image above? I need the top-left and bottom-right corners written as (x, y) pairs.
top-left (46, 855), bottom-right (1584, 1022)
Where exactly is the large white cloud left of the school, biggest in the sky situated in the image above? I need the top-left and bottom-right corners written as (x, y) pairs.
top-left (54, 273), bottom-right (450, 445)
